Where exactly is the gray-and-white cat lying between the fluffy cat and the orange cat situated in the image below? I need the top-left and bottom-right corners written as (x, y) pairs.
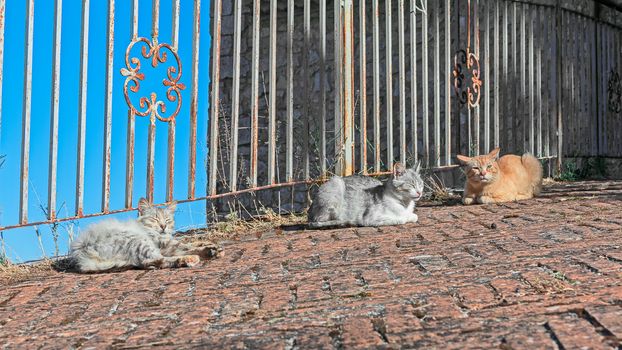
top-left (309, 163), bottom-right (424, 228)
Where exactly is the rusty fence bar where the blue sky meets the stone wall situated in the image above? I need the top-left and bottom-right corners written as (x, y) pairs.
top-left (208, 0), bottom-right (222, 195)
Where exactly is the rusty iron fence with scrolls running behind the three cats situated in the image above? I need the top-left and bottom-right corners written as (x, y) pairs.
top-left (0, 0), bottom-right (622, 231)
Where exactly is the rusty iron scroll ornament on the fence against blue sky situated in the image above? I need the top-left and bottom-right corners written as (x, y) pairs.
top-left (121, 38), bottom-right (186, 122)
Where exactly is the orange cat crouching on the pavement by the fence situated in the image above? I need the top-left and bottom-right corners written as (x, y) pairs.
top-left (458, 148), bottom-right (542, 205)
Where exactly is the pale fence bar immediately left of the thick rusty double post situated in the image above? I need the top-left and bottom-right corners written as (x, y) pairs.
top-left (320, 0), bottom-right (326, 177)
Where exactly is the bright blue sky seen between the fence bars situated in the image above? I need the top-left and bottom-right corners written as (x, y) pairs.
top-left (0, 0), bottom-right (210, 261)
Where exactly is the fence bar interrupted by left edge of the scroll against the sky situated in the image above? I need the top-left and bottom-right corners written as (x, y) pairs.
top-left (125, 0), bottom-right (138, 208)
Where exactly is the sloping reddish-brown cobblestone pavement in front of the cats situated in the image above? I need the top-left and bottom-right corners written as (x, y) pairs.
top-left (0, 182), bottom-right (622, 349)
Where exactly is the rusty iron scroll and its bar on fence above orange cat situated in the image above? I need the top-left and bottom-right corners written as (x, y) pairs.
top-left (453, 0), bottom-right (482, 107)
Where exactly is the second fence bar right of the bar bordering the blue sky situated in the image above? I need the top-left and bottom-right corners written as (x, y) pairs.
top-left (249, 0), bottom-right (261, 187)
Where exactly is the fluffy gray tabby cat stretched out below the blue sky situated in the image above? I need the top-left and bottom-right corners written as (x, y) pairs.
top-left (69, 198), bottom-right (219, 272)
